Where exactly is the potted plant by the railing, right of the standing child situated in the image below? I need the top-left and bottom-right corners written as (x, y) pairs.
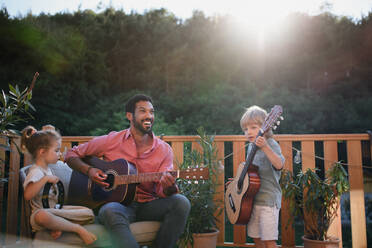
top-left (281, 162), bottom-right (349, 247)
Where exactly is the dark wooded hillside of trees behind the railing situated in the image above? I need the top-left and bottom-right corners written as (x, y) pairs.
top-left (0, 8), bottom-right (372, 135)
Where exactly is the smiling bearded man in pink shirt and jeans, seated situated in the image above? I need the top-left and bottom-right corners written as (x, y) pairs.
top-left (66, 95), bottom-right (190, 248)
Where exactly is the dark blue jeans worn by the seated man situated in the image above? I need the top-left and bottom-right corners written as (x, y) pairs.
top-left (98, 194), bottom-right (190, 248)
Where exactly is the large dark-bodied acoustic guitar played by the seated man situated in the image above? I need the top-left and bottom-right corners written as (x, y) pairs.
top-left (68, 157), bottom-right (209, 208)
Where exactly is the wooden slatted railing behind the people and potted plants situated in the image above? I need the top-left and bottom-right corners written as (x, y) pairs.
top-left (0, 134), bottom-right (372, 248)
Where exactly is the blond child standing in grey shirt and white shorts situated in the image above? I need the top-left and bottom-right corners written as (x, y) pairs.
top-left (240, 106), bottom-right (284, 248)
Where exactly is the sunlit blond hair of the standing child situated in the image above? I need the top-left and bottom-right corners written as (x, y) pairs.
top-left (240, 105), bottom-right (273, 138)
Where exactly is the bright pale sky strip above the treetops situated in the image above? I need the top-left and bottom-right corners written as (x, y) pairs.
top-left (0, 0), bottom-right (372, 22)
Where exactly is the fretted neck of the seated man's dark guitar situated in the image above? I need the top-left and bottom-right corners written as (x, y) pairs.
top-left (115, 170), bottom-right (179, 185)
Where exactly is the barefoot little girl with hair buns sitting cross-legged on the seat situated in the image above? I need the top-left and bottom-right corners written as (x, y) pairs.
top-left (21, 126), bottom-right (97, 245)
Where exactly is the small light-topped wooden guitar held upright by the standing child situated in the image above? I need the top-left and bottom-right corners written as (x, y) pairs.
top-left (225, 105), bottom-right (283, 225)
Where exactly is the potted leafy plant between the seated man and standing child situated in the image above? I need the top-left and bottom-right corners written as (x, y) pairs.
top-left (178, 128), bottom-right (222, 248)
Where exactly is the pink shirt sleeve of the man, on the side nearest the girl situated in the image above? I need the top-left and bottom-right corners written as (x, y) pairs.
top-left (65, 135), bottom-right (108, 160)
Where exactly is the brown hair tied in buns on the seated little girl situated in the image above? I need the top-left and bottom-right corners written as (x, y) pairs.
top-left (21, 126), bottom-right (61, 158)
